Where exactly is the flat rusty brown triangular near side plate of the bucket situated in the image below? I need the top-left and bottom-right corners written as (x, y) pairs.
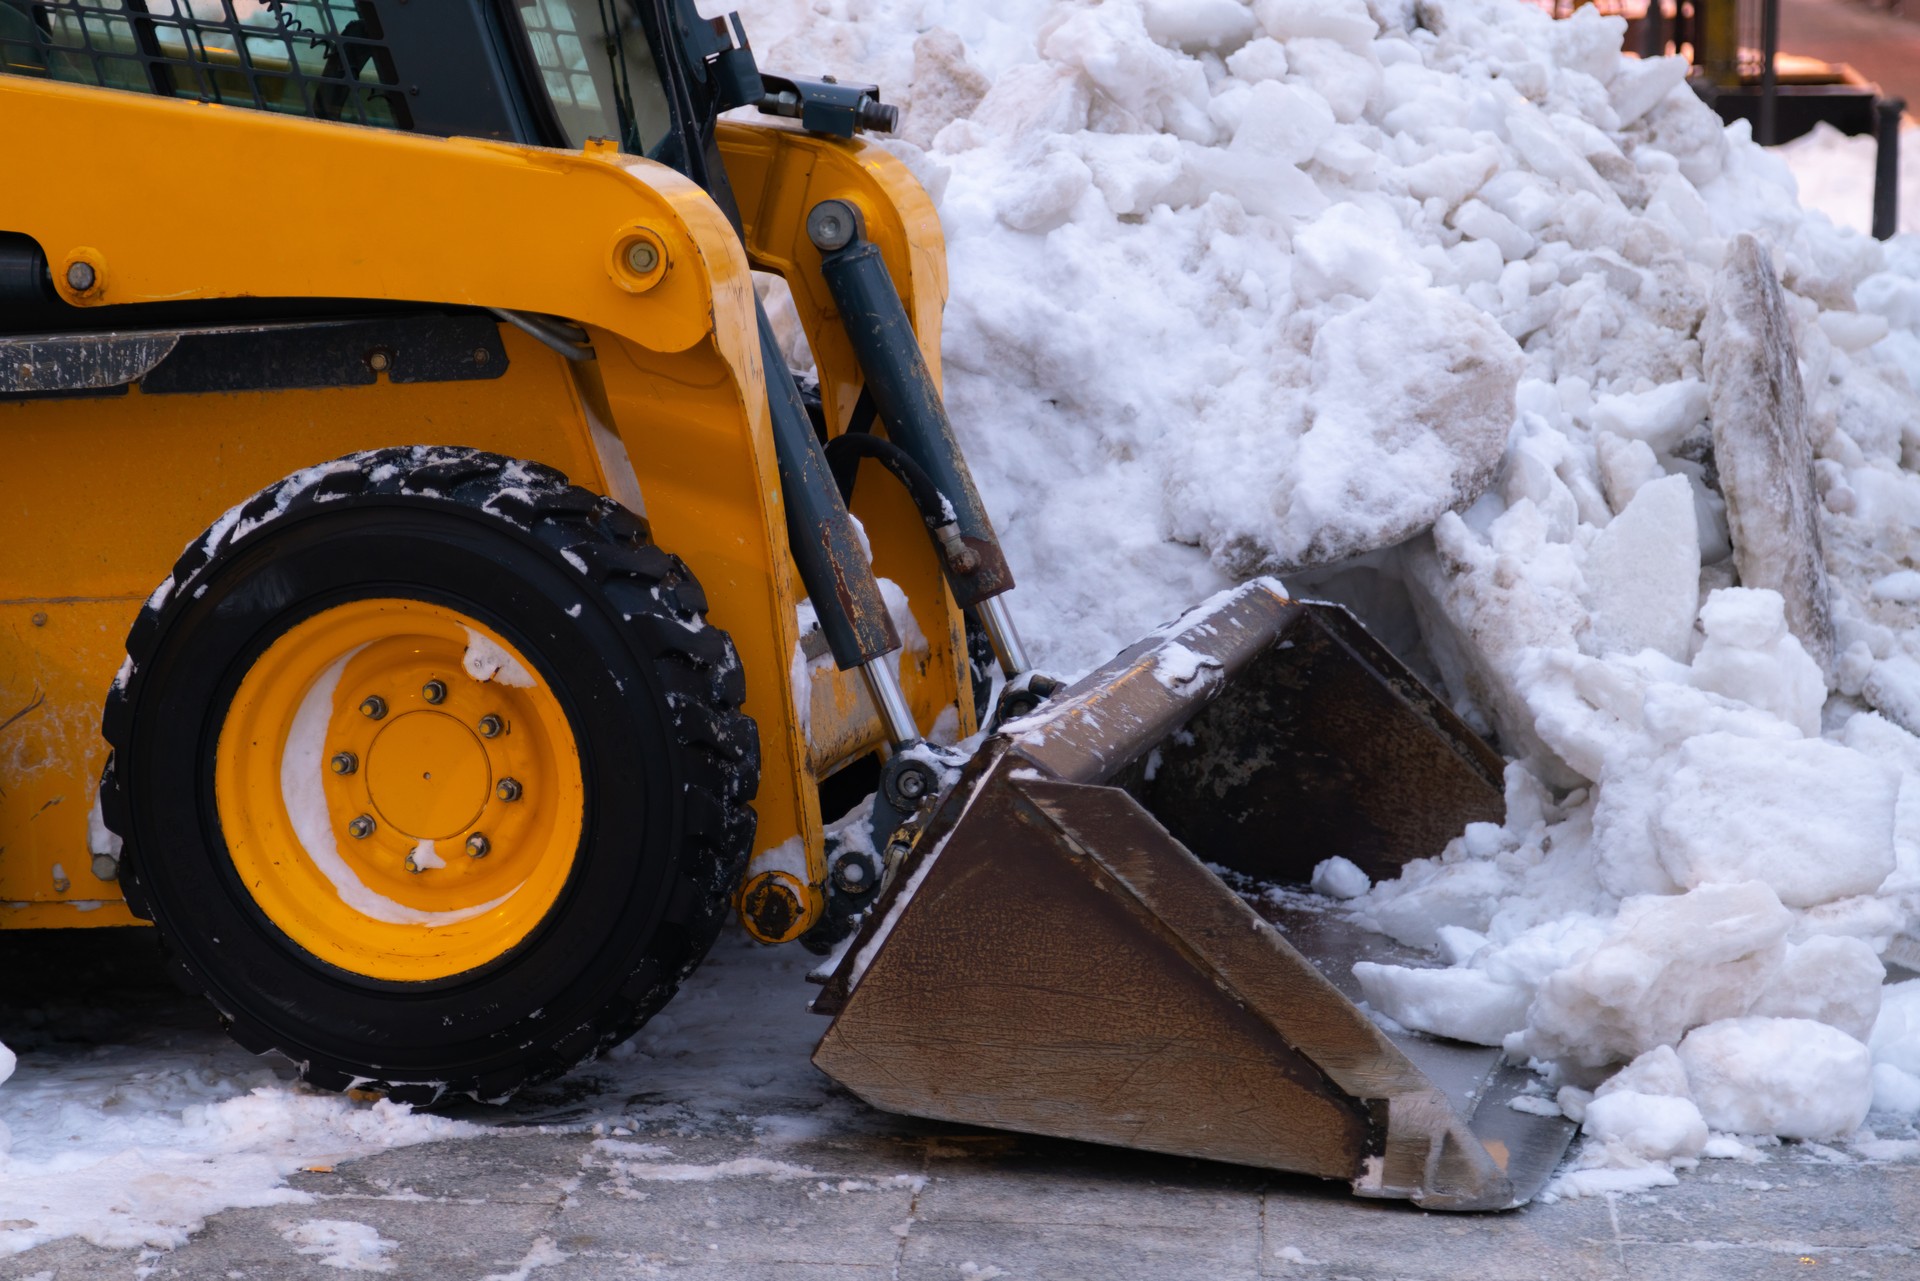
top-left (814, 759), bottom-right (1382, 1179)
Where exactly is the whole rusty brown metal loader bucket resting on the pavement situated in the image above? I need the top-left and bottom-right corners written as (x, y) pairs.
top-left (814, 584), bottom-right (1572, 1210)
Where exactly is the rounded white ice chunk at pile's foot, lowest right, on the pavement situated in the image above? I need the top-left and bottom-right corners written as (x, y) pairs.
top-left (1680, 1018), bottom-right (1874, 1139)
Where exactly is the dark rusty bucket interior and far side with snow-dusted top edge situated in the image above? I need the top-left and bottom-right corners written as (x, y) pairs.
top-left (1010, 582), bottom-right (1505, 882)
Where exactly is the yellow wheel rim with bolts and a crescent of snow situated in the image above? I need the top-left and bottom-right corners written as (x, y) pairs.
top-left (213, 599), bottom-right (586, 981)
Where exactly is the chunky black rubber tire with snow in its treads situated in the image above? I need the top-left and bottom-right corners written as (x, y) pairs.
top-left (102, 446), bottom-right (758, 1104)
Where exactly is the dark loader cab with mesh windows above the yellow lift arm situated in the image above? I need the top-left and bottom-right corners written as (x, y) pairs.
top-left (0, 0), bottom-right (737, 171)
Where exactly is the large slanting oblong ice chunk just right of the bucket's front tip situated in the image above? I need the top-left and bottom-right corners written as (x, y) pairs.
top-left (1524, 882), bottom-right (1793, 1075)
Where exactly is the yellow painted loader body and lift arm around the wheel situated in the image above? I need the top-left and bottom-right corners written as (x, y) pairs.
top-left (0, 77), bottom-right (973, 928)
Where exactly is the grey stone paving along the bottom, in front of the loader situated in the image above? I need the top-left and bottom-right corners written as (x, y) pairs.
top-left (11, 1124), bottom-right (1920, 1281)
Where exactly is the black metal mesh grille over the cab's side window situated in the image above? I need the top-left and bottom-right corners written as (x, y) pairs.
top-left (0, 0), bottom-right (411, 129)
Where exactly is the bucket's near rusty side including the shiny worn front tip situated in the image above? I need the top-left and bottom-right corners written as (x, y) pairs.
top-left (814, 749), bottom-right (1565, 1210)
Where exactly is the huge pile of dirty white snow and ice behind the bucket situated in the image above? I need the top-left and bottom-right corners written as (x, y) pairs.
top-left (725, 0), bottom-right (1920, 1191)
